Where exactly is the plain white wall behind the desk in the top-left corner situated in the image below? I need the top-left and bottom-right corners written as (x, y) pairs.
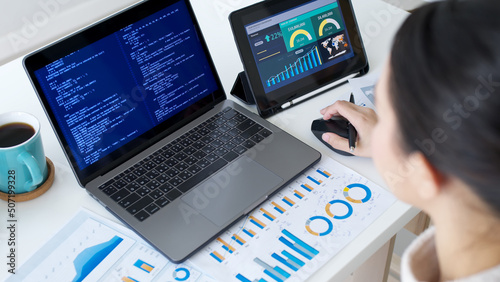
top-left (0, 0), bottom-right (138, 65)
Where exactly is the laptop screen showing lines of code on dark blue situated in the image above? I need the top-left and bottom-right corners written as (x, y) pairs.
top-left (25, 1), bottom-right (225, 183)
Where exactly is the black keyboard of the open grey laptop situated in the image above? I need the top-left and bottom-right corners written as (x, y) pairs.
top-left (99, 108), bottom-right (272, 221)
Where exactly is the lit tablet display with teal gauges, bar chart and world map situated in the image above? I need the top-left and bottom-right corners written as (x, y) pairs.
top-left (245, 0), bottom-right (354, 93)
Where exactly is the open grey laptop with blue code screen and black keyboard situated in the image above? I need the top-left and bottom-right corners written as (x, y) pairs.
top-left (24, 0), bottom-right (321, 262)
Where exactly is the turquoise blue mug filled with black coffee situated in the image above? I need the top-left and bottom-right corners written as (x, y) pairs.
top-left (0, 112), bottom-right (48, 194)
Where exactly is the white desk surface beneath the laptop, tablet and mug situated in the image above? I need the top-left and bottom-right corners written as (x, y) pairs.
top-left (0, 0), bottom-right (418, 281)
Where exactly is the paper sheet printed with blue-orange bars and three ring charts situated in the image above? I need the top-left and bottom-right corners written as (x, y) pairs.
top-left (191, 159), bottom-right (395, 282)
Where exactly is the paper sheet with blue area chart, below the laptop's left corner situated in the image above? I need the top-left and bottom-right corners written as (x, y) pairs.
top-left (6, 210), bottom-right (215, 282)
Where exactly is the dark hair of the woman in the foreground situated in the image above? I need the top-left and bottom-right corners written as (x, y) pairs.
top-left (389, 0), bottom-right (500, 216)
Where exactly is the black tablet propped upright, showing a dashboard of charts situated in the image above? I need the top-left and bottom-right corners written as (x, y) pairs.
top-left (229, 0), bottom-right (368, 117)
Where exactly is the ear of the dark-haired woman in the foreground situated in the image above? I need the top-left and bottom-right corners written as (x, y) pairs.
top-left (409, 152), bottom-right (445, 200)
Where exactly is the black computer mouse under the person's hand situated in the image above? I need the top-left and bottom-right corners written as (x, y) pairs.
top-left (311, 117), bottom-right (353, 156)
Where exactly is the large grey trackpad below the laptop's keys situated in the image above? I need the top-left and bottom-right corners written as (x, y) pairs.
top-left (182, 156), bottom-right (283, 226)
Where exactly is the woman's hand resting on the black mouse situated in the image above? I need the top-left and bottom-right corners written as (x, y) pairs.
top-left (320, 101), bottom-right (377, 157)
